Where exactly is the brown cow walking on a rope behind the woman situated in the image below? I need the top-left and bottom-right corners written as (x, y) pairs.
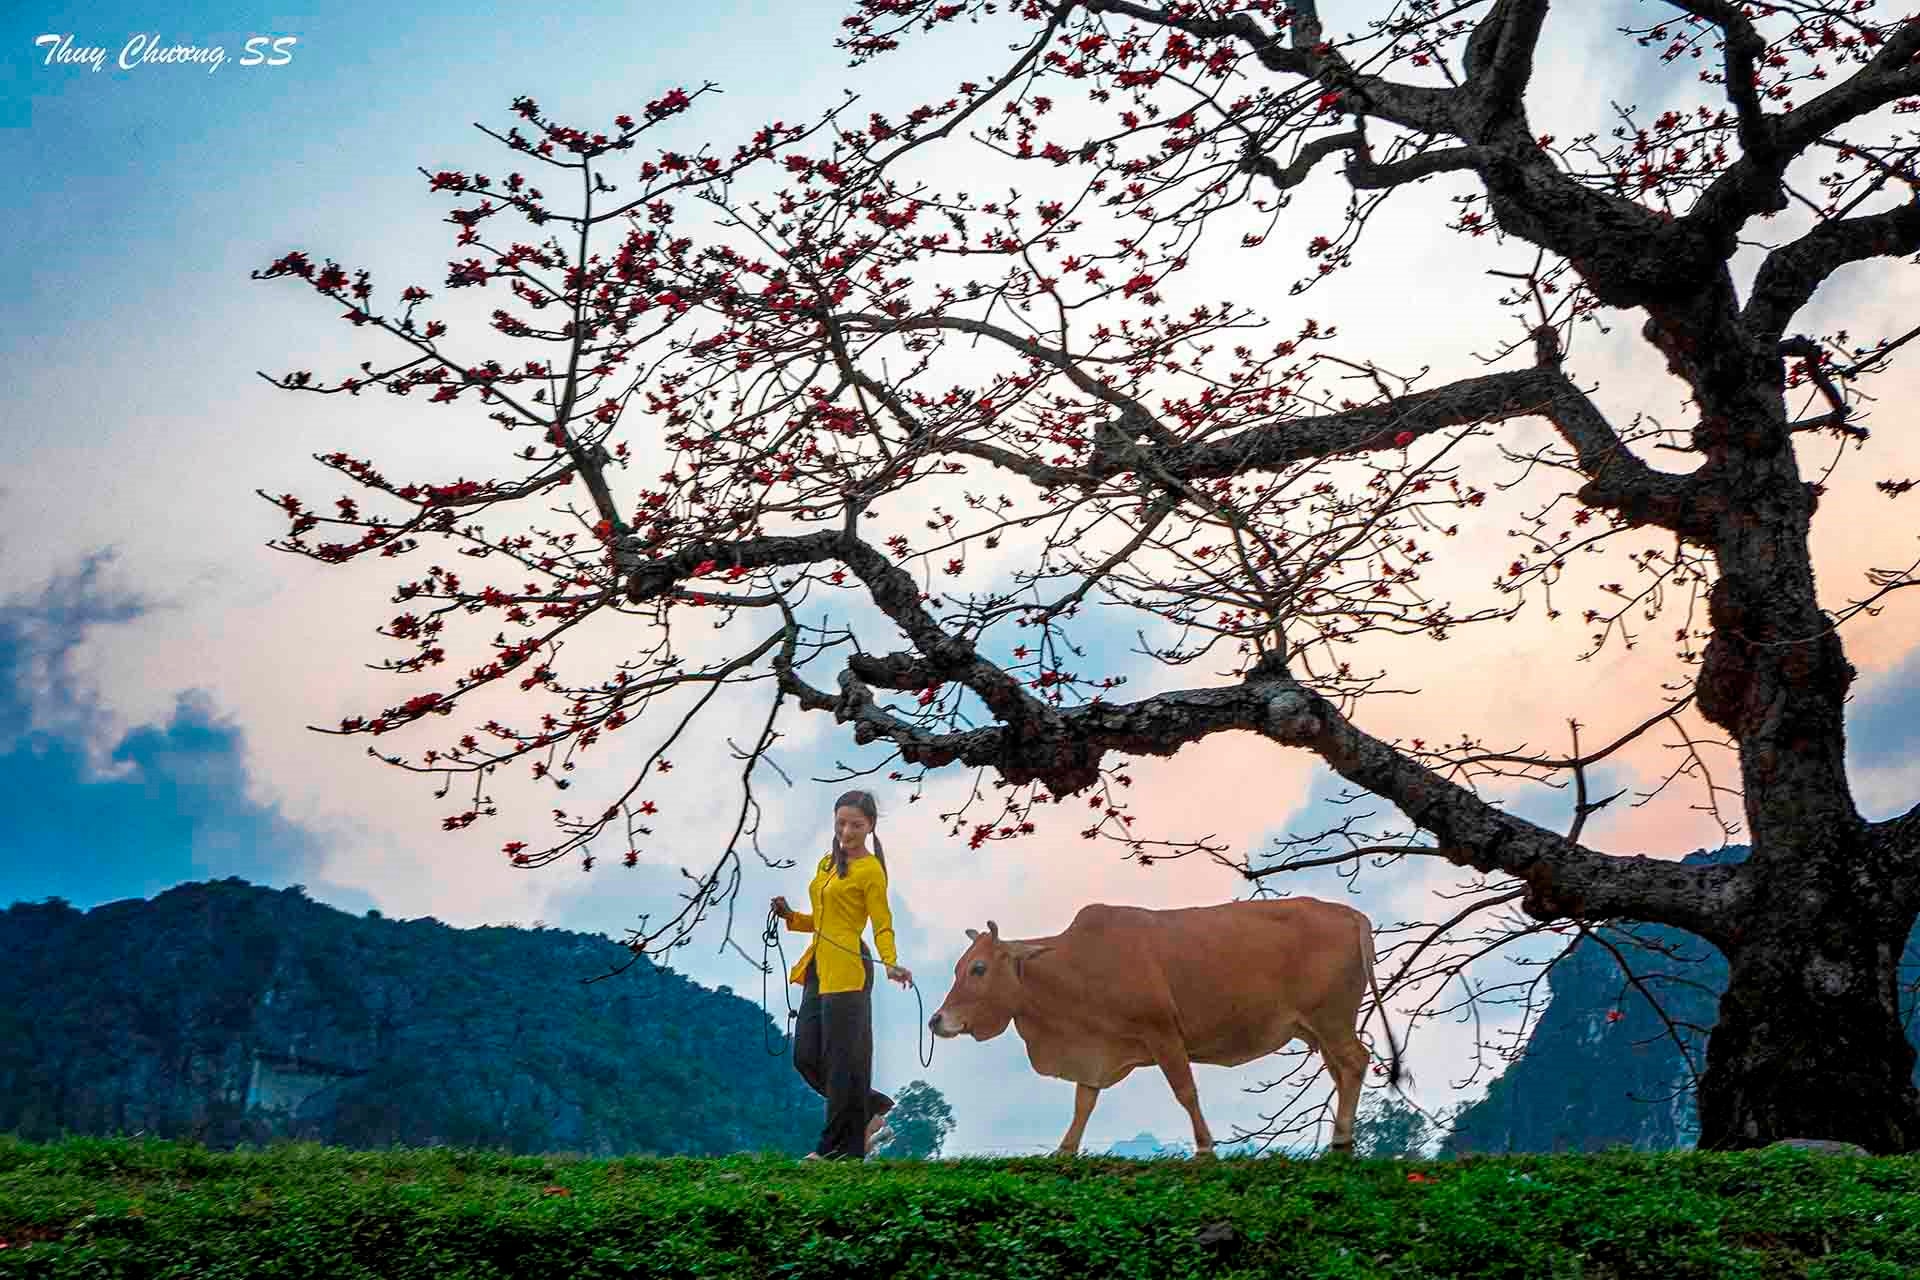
top-left (927, 898), bottom-right (1402, 1155)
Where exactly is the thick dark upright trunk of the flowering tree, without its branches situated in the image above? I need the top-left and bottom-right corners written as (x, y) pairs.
top-left (1647, 335), bottom-right (1920, 1153)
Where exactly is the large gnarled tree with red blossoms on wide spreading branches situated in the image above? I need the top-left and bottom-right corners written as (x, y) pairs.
top-left (259, 0), bottom-right (1920, 1151)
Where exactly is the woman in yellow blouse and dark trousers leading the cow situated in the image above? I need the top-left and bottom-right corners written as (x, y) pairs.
top-left (774, 791), bottom-right (914, 1159)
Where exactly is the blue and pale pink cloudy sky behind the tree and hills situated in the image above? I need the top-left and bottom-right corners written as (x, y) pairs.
top-left (11, 0), bottom-right (1920, 1153)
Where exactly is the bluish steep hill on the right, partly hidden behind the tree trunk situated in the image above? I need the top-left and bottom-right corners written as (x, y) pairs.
top-left (1440, 844), bottom-right (1920, 1155)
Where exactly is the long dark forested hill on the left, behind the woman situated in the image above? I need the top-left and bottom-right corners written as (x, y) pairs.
top-left (0, 879), bottom-right (820, 1155)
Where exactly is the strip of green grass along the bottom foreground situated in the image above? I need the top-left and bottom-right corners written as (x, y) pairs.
top-left (0, 1138), bottom-right (1920, 1280)
